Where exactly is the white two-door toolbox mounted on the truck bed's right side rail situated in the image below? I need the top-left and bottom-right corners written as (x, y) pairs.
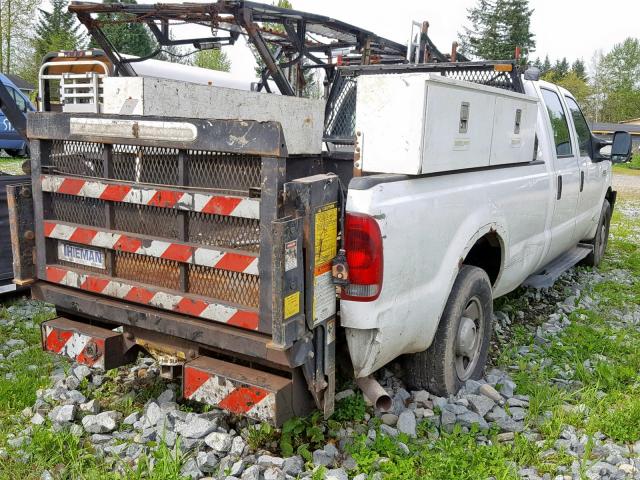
top-left (356, 73), bottom-right (538, 175)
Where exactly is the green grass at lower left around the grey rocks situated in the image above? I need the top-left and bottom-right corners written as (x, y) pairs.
top-left (0, 300), bottom-right (186, 480)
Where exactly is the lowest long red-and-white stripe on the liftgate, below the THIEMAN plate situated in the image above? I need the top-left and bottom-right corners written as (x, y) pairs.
top-left (46, 265), bottom-right (259, 330)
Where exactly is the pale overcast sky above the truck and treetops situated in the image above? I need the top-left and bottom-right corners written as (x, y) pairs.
top-left (132, 0), bottom-right (640, 79)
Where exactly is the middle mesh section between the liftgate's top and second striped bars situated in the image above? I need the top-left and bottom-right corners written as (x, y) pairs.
top-left (113, 203), bottom-right (181, 239)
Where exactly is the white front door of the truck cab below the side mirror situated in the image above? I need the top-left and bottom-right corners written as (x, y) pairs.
top-left (565, 95), bottom-right (607, 242)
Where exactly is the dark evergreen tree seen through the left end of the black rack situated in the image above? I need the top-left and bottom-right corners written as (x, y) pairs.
top-left (91, 0), bottom-right (157, 57)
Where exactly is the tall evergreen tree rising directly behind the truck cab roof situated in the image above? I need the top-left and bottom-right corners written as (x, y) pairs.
top-left (460, 0), bottom-right (536, 63)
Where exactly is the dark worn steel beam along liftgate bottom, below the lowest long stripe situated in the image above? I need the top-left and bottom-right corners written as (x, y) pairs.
top-left (32, 282), bottom-right (289, 368)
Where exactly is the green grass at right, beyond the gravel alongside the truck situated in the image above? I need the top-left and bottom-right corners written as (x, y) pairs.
top-left (498, 194), bottom-right (640, 460)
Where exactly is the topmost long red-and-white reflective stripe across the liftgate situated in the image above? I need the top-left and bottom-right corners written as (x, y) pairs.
top-left (41, 175), bottom-right (260, 219)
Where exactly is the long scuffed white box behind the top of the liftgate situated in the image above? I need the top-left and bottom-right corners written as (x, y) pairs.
top-left (103, 77), bottom-right (325, 155)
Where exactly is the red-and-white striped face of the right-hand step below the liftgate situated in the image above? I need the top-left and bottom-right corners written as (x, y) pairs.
top-left (182, 365), bottom-right (276, 422)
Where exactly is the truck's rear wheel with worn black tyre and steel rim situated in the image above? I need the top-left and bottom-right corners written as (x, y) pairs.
top-left (406, 265), bottom-right (493, 396)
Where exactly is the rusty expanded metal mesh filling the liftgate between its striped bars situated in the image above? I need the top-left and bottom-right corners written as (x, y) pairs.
top-left (44, 141), bottom-right (262, 322)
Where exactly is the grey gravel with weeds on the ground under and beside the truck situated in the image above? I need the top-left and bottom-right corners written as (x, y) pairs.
top-left (0, 183), bottom-right (640, 480)
